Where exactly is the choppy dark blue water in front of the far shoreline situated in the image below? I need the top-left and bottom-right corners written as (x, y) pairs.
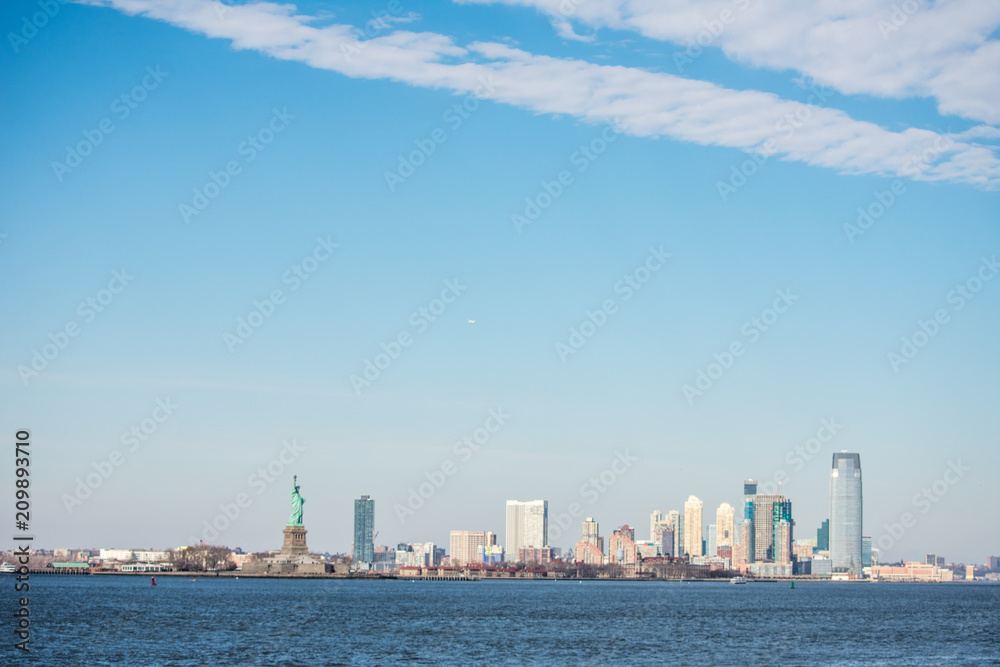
top-left (0, 576), bottom-right (1000, 667)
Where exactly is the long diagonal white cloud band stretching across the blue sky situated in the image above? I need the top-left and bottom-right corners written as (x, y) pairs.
top-left (90, 0), bottom-right (1000, 189)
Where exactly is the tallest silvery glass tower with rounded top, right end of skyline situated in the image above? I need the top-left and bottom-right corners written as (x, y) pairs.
top-left (830, 452), bottom-right (862, 577)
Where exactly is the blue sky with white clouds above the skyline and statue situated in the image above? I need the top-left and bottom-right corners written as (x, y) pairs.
top-left (0, 0), bottom-right (1000, 562)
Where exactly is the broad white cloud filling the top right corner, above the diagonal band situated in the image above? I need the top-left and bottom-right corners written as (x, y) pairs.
top-left (455, 0), bottom-right (1000, 125)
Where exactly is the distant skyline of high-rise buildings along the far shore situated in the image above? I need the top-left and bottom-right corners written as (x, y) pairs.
top-left (37, 451), bottom-right (993, 577)
